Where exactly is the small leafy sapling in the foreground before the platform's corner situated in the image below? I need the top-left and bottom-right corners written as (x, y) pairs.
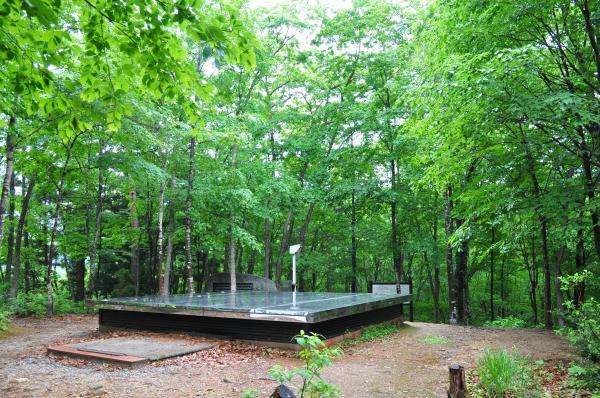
top-left (269, 330), bottom-right (343, 398)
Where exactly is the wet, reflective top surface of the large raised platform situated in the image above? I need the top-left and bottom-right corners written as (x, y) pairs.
top-left (94, 292), bottom-right (409, 322)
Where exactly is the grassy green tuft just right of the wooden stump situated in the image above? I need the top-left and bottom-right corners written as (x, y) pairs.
top-left (477, 349), bottom-right (536, 397)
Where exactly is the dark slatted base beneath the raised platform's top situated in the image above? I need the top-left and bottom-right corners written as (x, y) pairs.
top-left (99, 304), bottom-right (402, 343)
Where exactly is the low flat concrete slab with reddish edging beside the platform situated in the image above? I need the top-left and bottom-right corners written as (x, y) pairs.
top-left (48, 336), bottom-right (217, 366)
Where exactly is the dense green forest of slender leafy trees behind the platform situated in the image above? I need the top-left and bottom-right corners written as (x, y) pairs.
top-left (0, 0), bottom-right (600, 342)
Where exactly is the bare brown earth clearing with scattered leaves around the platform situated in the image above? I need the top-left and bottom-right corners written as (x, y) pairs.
top-left (0, 316), bottom-right (574, 398)
